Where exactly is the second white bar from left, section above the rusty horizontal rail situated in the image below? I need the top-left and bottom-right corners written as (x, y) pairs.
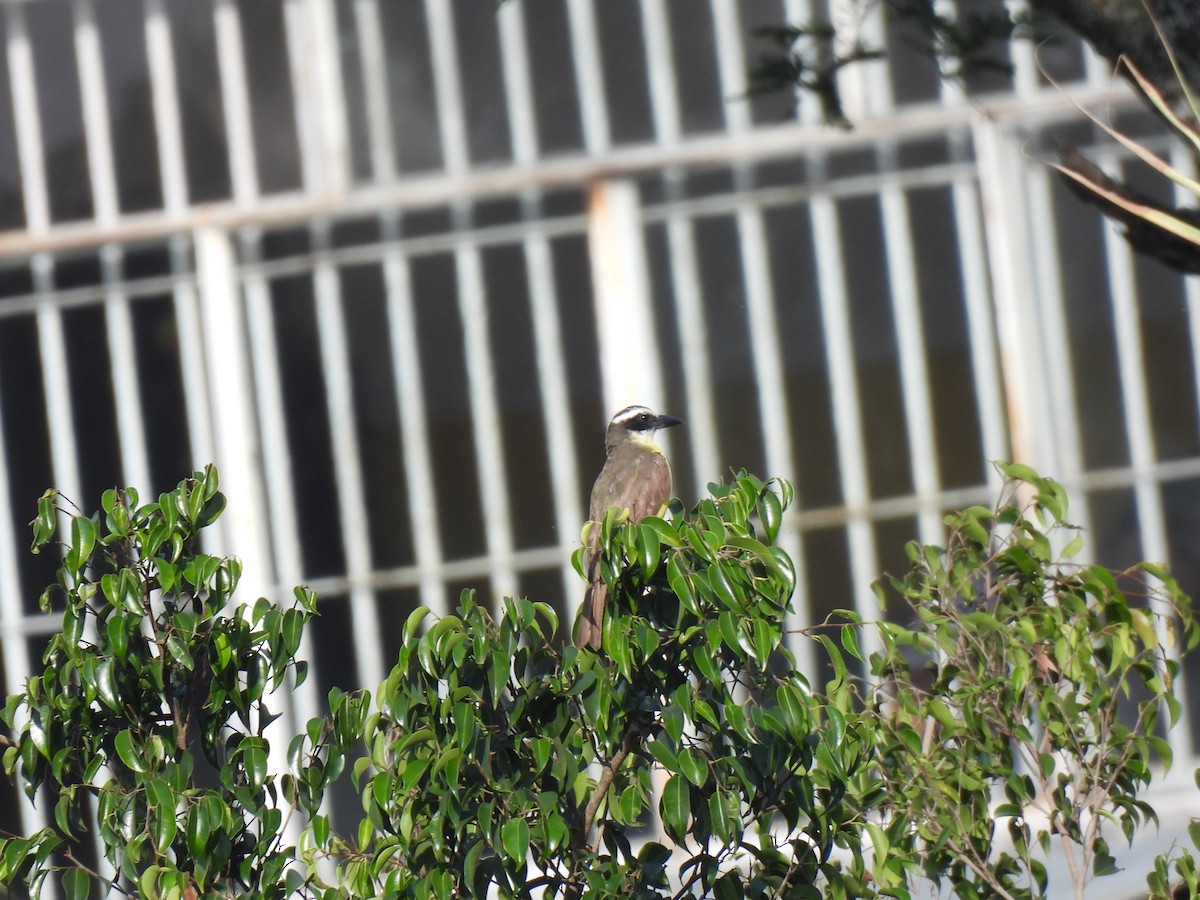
top-left (71, 0), bottom-right (119, 228)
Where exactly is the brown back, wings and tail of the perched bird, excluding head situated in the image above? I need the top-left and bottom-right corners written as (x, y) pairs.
top-left (577, 452), bottom-right (671, 649)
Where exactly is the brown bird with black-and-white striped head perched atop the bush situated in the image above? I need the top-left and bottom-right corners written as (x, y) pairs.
top-left (576, 406), bottom-right (683, 650)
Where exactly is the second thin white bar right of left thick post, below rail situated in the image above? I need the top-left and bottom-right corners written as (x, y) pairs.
top-left (312, 223), bottom-right (386, 685)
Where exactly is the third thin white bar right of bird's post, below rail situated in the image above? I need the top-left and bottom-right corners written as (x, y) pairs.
top-left (809, 183), bottom-right (880, 656)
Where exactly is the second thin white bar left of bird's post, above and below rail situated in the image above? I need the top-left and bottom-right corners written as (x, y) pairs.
top-left (425, 0), bottom-right (517, 596)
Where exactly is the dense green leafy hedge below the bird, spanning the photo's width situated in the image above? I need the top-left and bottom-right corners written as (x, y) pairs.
top-left (0, 467), bottom-right (1196, 900)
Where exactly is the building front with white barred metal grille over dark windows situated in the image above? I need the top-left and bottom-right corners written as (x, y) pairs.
top-left (0, 0), bottom-right (1200, 897)
